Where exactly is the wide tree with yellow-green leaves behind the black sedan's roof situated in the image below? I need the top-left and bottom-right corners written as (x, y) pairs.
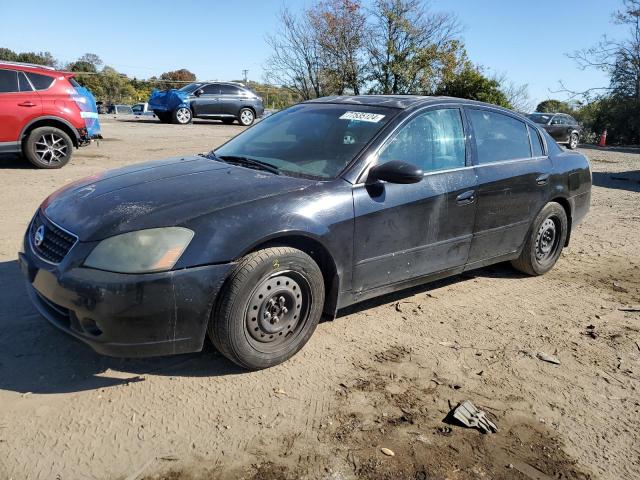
top-left (367, 0), bottom-right (466, 94)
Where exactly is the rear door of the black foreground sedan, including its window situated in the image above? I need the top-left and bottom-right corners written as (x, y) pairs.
top-left (466, 107), bottom-right (551, 268)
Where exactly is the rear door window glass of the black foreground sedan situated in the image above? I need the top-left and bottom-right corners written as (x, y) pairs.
top-left (468, 109), bottom-right (531, 164)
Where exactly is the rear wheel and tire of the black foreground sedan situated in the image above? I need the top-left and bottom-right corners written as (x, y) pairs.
top-left (511, 202), bottom-right (568, 275)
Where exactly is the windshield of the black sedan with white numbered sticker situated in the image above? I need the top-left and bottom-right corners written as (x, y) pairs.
top-left (214, 103), bottom-right (398, 179)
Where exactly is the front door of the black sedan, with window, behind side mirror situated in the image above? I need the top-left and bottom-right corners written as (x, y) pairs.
top-left (353, 108), bottom-right (476, 295)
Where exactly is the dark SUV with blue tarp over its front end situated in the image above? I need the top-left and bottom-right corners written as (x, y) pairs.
top-left (148, 82), bottom-right (264, 127)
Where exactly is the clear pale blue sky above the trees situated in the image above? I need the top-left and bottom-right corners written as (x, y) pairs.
top-left (0, 0), bottom-right (622, 107)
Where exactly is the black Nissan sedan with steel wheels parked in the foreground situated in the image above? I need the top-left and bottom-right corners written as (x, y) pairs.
top-left (19, 96), bottom-right (591, 369)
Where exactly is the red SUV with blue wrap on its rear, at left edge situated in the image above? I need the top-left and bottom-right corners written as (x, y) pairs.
top-left (0, 60), bottom-right (101, 168)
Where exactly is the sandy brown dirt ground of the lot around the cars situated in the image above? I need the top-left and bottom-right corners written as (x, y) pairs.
top-left (0, 119), bottom-right (640, 480)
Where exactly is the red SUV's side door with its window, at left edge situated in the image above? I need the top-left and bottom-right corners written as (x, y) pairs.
top-left (0, 68), bottom-right (42, 148)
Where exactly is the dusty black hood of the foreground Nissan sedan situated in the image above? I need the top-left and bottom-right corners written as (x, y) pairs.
top-left (41, 156), bottom-right (315, 241)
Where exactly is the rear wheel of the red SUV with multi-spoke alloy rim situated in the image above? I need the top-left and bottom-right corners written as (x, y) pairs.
top-left (23, 127), bottom-right (73, 169)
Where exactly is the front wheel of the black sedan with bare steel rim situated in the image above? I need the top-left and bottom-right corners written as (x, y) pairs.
top-left (208, 247), bottom-right (324, 370)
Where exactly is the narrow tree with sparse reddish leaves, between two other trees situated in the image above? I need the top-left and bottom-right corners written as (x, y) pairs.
top-left (308, 0), bottom-right (367, 95)
